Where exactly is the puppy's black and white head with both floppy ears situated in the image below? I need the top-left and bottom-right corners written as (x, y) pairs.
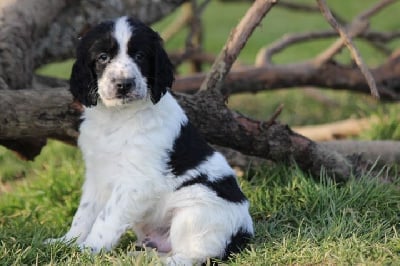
top-left (70, 17), bottom-right (173, 107)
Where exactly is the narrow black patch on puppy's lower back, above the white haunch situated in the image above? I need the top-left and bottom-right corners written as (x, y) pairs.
top-left (176, 175), bottom-right (247, 203)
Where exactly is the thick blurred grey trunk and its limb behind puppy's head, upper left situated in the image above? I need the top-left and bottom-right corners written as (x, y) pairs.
top-left (0, 0), bottom-right (185, 89)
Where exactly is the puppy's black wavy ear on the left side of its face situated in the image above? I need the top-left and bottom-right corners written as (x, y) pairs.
top-left (69, 56), bottom-right (98, 107)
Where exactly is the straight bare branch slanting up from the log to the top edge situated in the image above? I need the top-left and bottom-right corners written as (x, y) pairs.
top-left (200, 0), bottom-right (277, 91)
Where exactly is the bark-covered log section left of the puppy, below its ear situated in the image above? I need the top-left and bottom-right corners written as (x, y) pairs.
top-left (0, 88), bottom-right (81, 143)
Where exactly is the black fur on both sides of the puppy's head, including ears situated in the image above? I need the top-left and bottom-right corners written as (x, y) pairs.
top-left (70, 18), bottom-right (174, 107)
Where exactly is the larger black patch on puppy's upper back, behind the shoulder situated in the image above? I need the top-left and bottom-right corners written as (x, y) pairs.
top-left (168, 122), bottom-right (214, 176)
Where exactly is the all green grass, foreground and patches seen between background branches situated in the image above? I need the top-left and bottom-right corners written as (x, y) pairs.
top-left (0, 0), bottom-right (400, 265)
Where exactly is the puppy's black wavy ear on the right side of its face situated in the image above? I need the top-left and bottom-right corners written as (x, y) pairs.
top-left (150, 38), bottom-right (174, 104)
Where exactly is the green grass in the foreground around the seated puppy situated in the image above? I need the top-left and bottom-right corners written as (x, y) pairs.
top-left (0, 147), bottom-right (400, 265)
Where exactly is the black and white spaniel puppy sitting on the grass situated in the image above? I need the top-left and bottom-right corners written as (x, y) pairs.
top-left (47, 17), bottom-right (253, 265)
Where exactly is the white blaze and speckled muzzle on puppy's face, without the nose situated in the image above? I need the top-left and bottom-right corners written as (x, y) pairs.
top-left (98, 17), bottom-right (147, 106)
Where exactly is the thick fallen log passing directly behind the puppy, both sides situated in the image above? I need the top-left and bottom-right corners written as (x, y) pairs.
top-left (0, 87), bottom-right (352, 180)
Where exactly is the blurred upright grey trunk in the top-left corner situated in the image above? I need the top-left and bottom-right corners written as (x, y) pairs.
top-left (0, 0), bottom-right (65, 89)
